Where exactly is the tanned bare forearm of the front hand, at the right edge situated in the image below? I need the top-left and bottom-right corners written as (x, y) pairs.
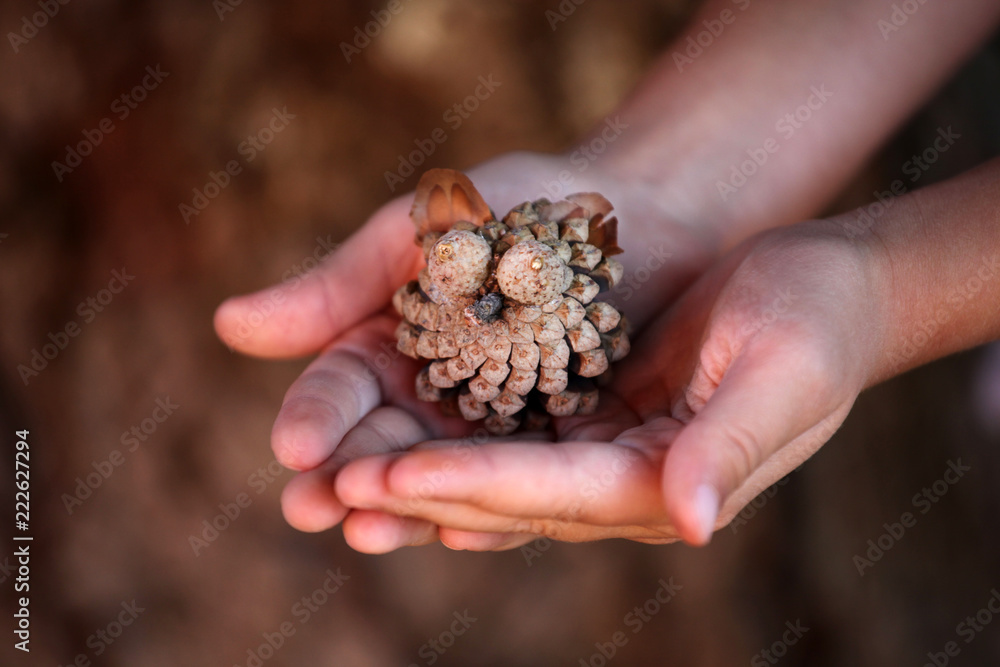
top-left (860, 160), bottom-right (1000, 384)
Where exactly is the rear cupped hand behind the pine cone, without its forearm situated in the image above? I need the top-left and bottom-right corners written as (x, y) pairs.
top-left (215, 153), bottom-right (716, 552)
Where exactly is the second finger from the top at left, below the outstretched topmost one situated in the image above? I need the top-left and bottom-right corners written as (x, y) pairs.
top-left (271, 317), bottom-right (402, 470)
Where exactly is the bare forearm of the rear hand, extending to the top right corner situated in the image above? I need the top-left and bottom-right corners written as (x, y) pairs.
top-left (606, 0), bottom-right (1000, 247)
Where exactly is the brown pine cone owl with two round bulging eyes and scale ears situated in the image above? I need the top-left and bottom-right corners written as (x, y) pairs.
top-left (393, 169), bottom-right (629, 435)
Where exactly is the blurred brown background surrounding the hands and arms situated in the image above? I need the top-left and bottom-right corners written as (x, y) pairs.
top-left (0, 0), bottom-right (1000, 667)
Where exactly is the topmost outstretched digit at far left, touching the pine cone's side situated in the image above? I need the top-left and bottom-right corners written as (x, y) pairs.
top-left (215, 198), bottom-right (423, 358)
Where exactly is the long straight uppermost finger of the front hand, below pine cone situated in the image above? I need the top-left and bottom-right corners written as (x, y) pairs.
top-left (338, 442), bottom-right (663, 532)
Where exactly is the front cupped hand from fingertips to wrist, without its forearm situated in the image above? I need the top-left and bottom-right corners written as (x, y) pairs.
top-left (335, 221), bottom-right (883, 550)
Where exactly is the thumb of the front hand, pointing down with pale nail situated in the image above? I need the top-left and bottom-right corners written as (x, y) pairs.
top-left (663, 349), bottom-right (850, 545)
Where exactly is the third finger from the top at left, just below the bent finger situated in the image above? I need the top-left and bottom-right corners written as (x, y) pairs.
top-left (281, 407), bottom-right (427, 533)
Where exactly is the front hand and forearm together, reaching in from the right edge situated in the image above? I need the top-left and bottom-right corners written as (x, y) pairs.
top-left (336, 154), bottom-right (1000, 549)
